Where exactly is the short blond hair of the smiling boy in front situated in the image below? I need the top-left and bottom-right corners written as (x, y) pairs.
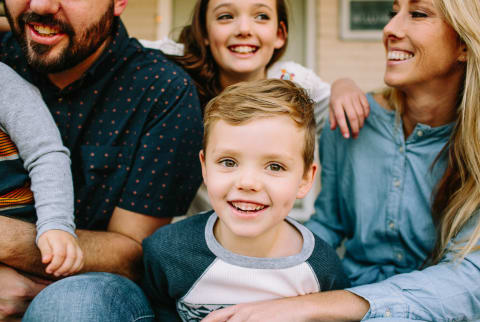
top-left (203, 79), bottom-right (315, 173)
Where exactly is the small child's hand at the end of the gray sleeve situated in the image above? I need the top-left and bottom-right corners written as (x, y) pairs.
top-left (38, 229), bottom-right (83, 277)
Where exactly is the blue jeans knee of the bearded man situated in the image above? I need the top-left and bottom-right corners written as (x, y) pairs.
top-left (22, 273), bottom-right (154, 322)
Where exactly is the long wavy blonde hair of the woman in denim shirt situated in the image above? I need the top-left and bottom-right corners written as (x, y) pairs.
top-left (383, 0), bottom-right (480, 264)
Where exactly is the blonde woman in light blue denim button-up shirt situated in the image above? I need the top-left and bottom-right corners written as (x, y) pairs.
top-left (205, 0), bottom-right (480, 322)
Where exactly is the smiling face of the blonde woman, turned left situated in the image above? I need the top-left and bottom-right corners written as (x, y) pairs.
top-left (383, 0), bottom-right (466, 89)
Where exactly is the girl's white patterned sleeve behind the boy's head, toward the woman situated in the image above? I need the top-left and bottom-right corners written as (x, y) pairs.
top-left (267, 61), bottom-right (330, 101)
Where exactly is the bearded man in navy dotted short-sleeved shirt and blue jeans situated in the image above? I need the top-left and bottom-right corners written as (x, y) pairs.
top-left (0, 0), bottom-right (202, 321)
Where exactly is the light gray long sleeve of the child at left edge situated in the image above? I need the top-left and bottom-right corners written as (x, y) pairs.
top-left (0, 63), bottom-right (75, 240)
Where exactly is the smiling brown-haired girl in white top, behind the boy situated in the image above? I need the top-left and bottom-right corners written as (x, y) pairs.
top-left (141, 0), bottom-right (369, 138)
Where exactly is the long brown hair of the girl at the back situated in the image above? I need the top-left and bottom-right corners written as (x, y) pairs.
top-left (169, 0), bottom-right (288, 106)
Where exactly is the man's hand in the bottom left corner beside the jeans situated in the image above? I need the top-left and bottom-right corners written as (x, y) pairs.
top-left (0, 264), bottom-right (49, 322)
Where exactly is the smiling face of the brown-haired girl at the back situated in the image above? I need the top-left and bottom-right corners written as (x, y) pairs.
top-left (206, 0), bottom-right (286, 83)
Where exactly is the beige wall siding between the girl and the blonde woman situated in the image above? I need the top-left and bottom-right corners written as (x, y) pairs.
top-left (316, 0), bottom-right (385, 91)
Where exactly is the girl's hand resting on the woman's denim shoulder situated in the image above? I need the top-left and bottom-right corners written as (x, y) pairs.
top-left (329, 78), bottom-right (370, 139)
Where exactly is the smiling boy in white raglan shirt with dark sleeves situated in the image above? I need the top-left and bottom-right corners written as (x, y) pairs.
top-left (143, 79), bottom-right (349, 321)
